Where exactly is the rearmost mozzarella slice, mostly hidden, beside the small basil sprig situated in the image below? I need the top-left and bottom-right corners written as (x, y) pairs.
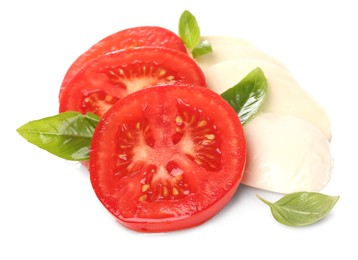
top-left (196, 45), bottom-right (286, 69)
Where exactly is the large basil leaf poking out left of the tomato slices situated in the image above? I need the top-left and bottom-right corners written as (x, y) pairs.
top-left (17, 111), bottom-right (99, 161)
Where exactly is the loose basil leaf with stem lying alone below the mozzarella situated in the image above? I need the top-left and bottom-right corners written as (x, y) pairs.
top-left (257, 192), bottom-right (339, 226)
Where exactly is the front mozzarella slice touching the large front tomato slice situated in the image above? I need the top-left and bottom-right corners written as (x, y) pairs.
top-left (242, 113), bottom-right (333, 193)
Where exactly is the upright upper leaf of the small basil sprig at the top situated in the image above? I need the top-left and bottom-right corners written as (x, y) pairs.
top-left (179, 10), bottom-right (200, 49)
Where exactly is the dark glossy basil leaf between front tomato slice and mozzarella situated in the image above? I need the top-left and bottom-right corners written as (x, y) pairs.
top-left (221, 68), bottom-right (267, 124)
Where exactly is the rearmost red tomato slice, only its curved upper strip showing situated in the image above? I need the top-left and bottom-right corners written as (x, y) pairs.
top-left (60, 26), bottom-right (186, 90)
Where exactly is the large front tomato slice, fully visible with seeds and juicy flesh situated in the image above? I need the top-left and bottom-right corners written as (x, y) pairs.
top-left (90, 84), bottom-right (246, 232)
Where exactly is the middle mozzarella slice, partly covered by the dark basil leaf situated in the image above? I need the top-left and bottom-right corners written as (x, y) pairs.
top-left (203, 59), bottom-right (331, 140)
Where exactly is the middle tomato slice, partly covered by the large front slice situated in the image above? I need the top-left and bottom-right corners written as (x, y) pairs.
top-left (60, 47), bottom-right (205, 116)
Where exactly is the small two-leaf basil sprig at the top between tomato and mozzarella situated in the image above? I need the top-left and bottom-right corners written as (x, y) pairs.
top-left (179, 10), bottom-right (213, 58)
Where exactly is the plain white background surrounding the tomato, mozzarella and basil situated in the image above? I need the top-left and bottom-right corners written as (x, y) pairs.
top-left (0, 0), bottom-right (358, 260)
